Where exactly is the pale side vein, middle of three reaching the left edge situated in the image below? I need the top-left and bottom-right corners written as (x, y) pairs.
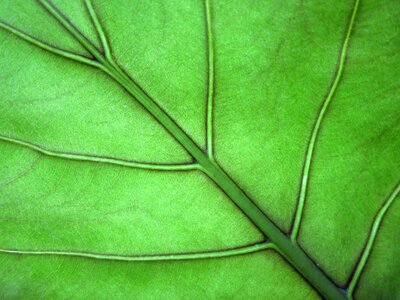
top-left (0, 134), bottom-right (198, 171)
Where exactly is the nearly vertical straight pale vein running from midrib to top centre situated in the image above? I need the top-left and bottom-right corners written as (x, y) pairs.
top-left (204, 0), bottom-right (215, 159)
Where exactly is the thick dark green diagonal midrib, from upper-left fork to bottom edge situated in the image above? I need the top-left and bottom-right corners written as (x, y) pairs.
top-left (101, 57), bottom-right (347, 299)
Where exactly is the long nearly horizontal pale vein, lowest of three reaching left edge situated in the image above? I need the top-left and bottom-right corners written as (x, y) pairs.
top-left (0, 243), bottom-right (274, 262)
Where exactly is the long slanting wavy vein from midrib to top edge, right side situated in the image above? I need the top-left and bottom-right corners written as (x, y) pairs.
top-left (291, 0), bottom-right (360, 242)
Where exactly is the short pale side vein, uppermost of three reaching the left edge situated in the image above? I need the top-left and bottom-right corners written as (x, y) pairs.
top-left (0, 21), bottom-right (101, 68)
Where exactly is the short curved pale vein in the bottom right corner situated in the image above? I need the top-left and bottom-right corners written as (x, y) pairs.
top-left (347, 183), bottom-right (400, 298)
